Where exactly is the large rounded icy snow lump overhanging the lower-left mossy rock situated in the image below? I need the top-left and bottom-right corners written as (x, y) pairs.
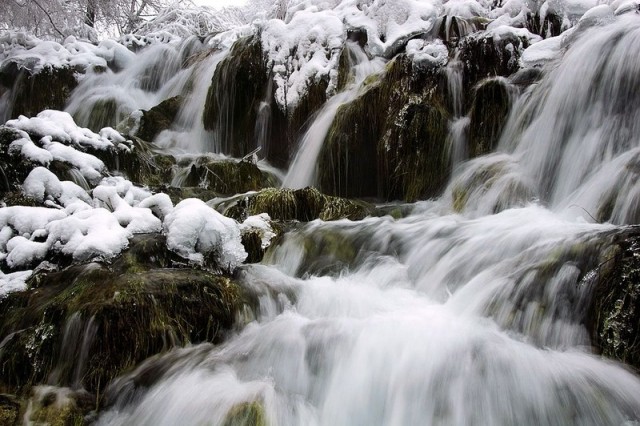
top-left (164, 198), bottom-right (247, 270)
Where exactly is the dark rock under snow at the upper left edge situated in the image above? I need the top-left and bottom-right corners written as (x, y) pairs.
top-left (0, 62), bottom-right (78, 118)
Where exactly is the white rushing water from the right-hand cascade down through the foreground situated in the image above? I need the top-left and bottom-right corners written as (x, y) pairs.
top-left (99, 17), bottom-right (640, 426)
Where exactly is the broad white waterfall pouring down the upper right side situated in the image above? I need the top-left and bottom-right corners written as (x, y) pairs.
top-left (448, 16), bottom-right (640, 223)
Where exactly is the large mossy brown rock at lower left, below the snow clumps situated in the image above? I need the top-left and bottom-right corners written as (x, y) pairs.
top-left (0, 235), bottom-right (244, 393)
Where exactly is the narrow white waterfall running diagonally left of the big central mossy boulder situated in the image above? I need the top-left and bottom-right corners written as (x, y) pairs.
top-left (282, 42), bottom-right (384, 189)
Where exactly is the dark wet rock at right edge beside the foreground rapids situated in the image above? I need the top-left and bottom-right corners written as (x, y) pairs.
top-left (588, 227), bottom-right (640, 369)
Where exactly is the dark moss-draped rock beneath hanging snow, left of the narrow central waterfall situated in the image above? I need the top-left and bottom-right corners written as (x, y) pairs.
top-left (203, 36), bottom-right (328, 167)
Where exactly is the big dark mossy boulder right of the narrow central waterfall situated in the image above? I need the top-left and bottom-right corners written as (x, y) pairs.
top-left (318, 55), bottom-right (451, 201)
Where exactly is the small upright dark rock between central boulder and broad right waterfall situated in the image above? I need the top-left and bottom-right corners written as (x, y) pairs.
top-left (469, 78), bottom-right (511, 158)
